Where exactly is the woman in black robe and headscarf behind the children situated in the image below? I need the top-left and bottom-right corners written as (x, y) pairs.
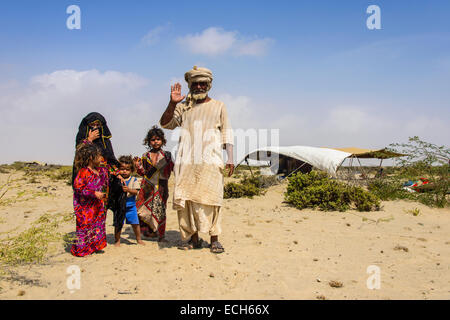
top-left (72, 112), bottom-right (126, 232)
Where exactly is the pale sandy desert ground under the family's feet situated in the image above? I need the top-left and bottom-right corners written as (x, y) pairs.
top-left (0, 173), bottom-right (450, 299)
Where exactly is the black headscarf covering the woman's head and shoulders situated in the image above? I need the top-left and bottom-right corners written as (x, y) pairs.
top-left (75, 112), bottom-right (119, 166)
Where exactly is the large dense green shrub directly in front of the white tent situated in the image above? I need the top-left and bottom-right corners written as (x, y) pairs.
top-left (285, 171), bottom-right (380, 211)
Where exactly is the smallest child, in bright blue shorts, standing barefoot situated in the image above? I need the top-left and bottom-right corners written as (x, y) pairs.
top-left (114, 156), bottom-right (145, 247)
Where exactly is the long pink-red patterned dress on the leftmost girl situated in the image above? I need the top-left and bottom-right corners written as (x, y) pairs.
top-left (71, 167), bottom-right (108, 257)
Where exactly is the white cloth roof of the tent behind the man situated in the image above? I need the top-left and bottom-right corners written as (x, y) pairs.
top-left (238, 146), bottom-right (352, 177)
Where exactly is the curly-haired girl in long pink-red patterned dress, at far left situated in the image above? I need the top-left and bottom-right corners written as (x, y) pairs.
top-left (70, 144), bottom-right (108, 257)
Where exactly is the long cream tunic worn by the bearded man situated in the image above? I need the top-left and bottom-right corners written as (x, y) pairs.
top-left (162, 99), bottom-right (233, 210)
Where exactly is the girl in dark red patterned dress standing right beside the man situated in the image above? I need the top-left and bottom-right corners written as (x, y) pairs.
top-left (135, 126), bottom-right (174, 241)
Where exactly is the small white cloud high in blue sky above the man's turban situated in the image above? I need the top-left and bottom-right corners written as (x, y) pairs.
top-left (177, 27), bottom-right (274, 56)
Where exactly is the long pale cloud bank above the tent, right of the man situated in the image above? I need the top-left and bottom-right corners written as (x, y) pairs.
top-left (213, 93), bottom-right (450, 156)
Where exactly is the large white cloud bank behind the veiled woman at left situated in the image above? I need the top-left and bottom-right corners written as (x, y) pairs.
top-left (0, 70), bottom-right (162, 164)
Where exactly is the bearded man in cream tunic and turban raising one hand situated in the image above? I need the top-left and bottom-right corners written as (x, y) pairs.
top-left (160, 66), bottom-right (234, 253)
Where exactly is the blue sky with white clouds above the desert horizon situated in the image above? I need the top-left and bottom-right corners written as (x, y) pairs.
top-left (0, 0), bottom-right (450, 163)
